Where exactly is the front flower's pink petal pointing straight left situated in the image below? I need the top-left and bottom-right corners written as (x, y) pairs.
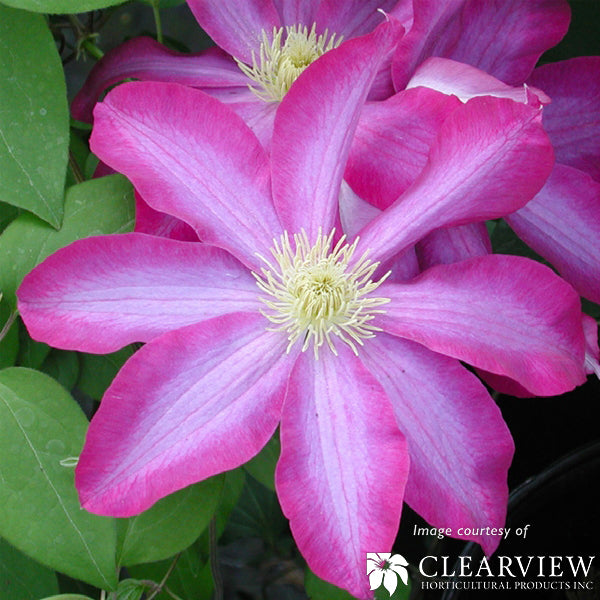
top-left (18, 233), bottom-right (261, 353)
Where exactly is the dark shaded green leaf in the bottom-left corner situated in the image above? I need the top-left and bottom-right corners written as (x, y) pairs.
top-left (0, 538), bottom-right (58, 600)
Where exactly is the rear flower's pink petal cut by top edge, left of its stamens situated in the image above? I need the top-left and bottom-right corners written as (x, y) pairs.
top-left (187, 0), bottom-right (281, 64)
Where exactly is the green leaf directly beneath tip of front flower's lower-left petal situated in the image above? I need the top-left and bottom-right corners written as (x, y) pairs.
top-left (117, 476), bottom-right (224, 566)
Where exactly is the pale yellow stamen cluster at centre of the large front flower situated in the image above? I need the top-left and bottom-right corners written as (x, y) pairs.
top-left (254, 230), bottom-right (390, 358)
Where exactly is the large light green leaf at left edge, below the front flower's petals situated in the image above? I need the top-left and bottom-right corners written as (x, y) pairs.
top-left (0, 367), bottom-right (117, 589)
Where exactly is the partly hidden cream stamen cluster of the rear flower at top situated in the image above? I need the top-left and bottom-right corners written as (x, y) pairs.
top-left (236, 23), bottom-right (342, 102)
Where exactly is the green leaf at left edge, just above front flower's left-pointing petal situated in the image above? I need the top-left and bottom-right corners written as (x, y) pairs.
top-left (0, 175), bottom-right (135, 306)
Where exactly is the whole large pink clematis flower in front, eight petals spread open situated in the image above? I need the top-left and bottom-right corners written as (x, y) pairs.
top-left (18, 23), bottom-right (585, 599)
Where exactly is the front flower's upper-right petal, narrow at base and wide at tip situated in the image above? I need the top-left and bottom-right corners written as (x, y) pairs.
top-left (358, 96), bottom-right (554, 260)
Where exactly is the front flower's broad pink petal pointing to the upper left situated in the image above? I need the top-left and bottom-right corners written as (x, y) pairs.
top-left (90, 82), bottom-right (281, 266)
